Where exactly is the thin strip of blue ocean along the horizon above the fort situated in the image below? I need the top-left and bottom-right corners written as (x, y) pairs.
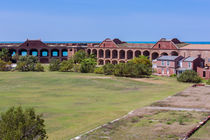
top-left (0, 41), bottom-right (210, 44)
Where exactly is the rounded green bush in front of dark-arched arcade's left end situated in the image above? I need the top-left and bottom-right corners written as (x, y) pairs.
top-left (80, 58), bottom-right (96, 73)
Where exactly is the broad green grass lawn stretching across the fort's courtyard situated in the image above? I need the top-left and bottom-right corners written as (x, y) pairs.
top-left (0, 72), bottom-right (190, 140)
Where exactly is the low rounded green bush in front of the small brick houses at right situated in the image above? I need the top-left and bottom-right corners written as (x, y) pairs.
top-left (177, 70), bottom-right (201, 83)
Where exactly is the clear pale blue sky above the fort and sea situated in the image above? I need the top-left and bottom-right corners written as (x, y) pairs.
top-left (0, 0), bottom-right (210, 41)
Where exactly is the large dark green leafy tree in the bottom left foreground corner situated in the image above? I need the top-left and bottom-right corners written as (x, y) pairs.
top-left (0, 107), bottom-right (47, 140)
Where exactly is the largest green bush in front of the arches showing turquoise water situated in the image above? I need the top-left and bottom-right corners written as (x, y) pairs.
top-left (16, 56), bottom-right (38, 72)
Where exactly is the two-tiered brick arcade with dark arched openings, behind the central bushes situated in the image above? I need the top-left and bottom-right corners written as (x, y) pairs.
top-left (87, 48), bottom-right (178, 65)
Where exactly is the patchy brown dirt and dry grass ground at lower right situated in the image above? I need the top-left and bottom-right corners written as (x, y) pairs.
top-left (81, 86), bottom-right (210, 140)
